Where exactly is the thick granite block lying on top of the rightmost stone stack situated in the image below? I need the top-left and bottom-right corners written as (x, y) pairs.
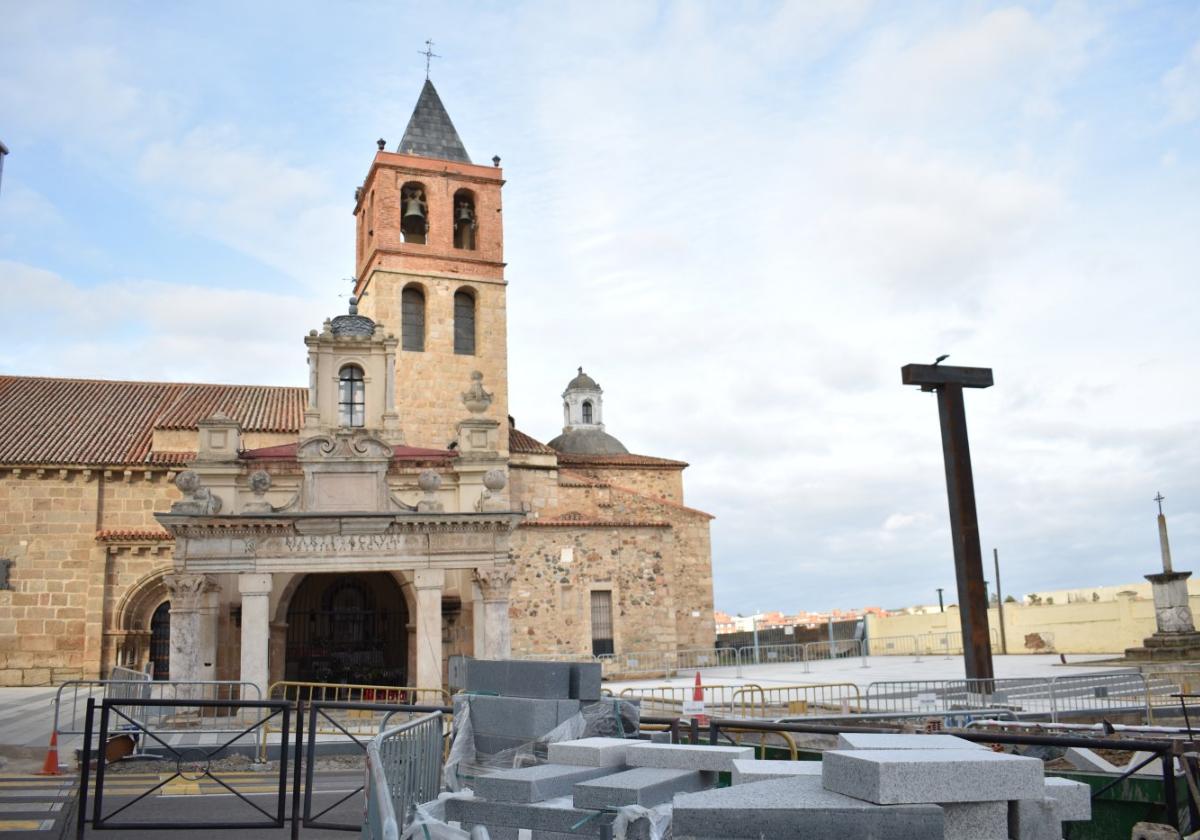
top-left (821, 750), bottom-right (1041, 806)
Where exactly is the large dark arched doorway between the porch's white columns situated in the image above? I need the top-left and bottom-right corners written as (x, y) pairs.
top-left (284, 572), bottom-right (408, 685)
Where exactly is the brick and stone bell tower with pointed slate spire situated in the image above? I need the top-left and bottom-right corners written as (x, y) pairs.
top-left (354, 79), bottom-right (509, 455)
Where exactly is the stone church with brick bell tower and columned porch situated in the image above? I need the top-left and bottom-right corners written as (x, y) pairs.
top-left (0, 80), bottom-right (715, 692)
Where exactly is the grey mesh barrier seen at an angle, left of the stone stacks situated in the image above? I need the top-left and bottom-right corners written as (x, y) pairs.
top-left (362, 712), bottom-right (443, 840)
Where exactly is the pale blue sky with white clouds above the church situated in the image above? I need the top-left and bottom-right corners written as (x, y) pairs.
top-left (0, 0), bottom-right (1200, 612)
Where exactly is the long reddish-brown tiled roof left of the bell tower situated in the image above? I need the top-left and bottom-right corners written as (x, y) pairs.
top-left (0, 377), bottom-right (308, 464)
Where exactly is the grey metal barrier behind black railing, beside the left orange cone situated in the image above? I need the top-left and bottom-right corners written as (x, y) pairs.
top-left (53, 679), bottom-right (262, 736)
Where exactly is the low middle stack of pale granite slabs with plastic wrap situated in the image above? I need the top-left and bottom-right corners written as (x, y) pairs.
top-left (446, 738), bottom-right (754, 840)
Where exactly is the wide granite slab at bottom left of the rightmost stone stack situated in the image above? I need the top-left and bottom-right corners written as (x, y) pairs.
top-left (671, 775), bottom-right (944, 840)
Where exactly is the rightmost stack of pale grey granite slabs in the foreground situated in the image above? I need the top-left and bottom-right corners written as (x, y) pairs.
top-left (672, 734), bottom-right (1091, 840)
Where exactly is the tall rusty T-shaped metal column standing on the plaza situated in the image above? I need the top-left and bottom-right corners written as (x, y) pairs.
top-left (901, 364), bottom-right (995, 681)
